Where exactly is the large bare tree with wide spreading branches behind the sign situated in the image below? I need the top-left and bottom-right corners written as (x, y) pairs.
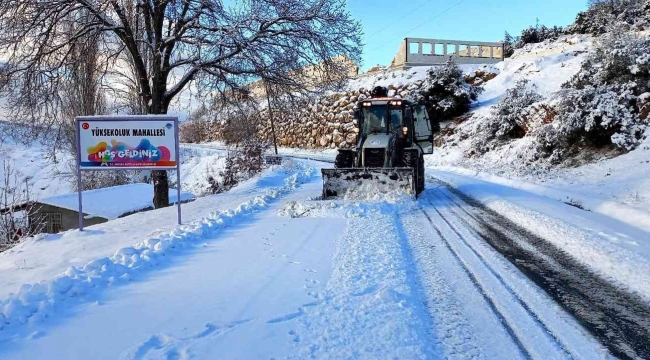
top-left (0, 0), bottom-right (361, 208)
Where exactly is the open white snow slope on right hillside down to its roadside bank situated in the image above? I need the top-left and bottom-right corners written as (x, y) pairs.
top-left (416, 36), bottom-right (650, 223)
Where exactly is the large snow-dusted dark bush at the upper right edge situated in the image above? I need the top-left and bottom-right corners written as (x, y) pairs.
top-left (554, 33), bottom-right (650, 151)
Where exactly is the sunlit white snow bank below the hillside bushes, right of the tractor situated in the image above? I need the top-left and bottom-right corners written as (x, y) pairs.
top-left (425, 124), bottom-right (650, 222)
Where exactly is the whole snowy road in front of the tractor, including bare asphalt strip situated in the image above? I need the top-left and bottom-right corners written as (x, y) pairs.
top-left (0, 162), bottom-right (650, 359)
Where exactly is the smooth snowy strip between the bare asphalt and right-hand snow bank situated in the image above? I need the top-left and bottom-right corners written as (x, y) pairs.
top-left (428, 170), bottom-right (650, 303)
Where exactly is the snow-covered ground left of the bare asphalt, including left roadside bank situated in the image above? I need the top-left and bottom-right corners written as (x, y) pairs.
top-left (0, 160), bottom-right (624, 359)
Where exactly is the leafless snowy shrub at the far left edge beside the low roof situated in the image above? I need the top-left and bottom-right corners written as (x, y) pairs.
top-left (0, 161), bottom-right (43, 252)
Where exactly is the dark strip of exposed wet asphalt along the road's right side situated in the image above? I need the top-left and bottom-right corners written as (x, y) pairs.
top-left (430, 183), bottom-right (650, 359)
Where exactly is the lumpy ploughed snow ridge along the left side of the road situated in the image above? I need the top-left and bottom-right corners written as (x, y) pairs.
top-left (0, 167), bottom-right (316, 338)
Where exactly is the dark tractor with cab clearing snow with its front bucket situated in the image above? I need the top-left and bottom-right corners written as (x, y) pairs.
top-left (322, 87), bottom-right (433, 199)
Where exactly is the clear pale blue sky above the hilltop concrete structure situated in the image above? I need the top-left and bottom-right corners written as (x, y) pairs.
top-left (348, 0), bottom-right (587, 70)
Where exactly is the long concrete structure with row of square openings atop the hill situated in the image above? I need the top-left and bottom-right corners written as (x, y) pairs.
top-left (391, 38), bottom-right (503, 69)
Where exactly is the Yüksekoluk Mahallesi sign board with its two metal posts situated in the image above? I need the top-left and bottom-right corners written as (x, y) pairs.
top-left (76, 115), bottom-right (181, 231)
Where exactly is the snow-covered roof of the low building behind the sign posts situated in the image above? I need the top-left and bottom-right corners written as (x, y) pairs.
top-left (38, 183), bottom-right (194, 220)
